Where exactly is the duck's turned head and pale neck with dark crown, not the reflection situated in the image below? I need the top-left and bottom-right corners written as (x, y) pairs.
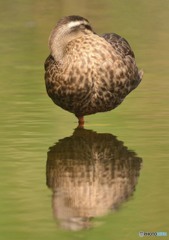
top-left (49, 15), bottom-right (93, 60)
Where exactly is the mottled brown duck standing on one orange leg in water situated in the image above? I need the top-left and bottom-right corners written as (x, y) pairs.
top-left (44, 15), bottom-right (143, 126)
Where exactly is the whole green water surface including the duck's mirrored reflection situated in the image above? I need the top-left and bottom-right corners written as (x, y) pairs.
top-left (0, 0), bottom-right (169, 240)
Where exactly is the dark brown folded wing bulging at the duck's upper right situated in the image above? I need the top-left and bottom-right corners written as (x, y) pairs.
top-left (101, 33), bottom-right (135, 58)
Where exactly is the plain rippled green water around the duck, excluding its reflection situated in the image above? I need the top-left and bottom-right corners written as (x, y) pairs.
top-left (0, 0), bottom-right (169, 240)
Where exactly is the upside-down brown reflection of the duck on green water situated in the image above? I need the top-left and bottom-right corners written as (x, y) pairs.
top-left (47, 128), bottom-right (142, 230)
